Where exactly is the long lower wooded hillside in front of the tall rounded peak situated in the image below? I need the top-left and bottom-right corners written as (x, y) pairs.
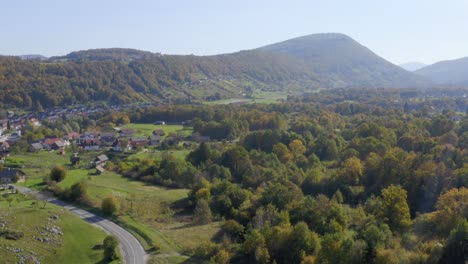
top-left (0, 50), bottom-right (319, 109)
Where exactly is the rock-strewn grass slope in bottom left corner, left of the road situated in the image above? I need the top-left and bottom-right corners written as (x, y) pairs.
top-left (0, 193), bottom-right (118, 263)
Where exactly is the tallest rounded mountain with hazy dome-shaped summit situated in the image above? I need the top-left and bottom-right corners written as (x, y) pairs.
top-left (260, 33), bottom-right (424, 88)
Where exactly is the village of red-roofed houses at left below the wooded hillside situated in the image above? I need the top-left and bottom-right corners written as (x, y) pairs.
top-left (0, 109), bottom-right (205, 188)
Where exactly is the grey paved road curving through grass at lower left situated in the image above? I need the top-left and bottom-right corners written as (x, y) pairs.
top-left (16, 186), bottom-right (147, 264)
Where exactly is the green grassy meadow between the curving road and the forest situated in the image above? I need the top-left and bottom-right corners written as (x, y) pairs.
top-left (14, 146), bottom-right (219, 263)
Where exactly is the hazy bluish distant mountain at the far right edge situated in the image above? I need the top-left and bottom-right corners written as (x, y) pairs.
top-left (415, 57), bottom-right (468, 85)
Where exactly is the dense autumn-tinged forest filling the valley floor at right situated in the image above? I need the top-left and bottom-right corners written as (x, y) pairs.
top-left (17, 89), bottom-right (468, 263)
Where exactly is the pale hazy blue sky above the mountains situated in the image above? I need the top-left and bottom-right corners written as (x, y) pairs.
top-left (0, 0), bottom-right (468, 63)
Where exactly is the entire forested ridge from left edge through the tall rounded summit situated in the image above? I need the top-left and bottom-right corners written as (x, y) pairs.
top-left (0, 34), bottom-right (425, 110)
